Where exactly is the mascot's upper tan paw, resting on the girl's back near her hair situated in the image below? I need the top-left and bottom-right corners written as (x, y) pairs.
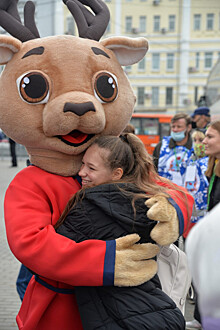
top-left (145, 195), bottom-right (179, 245)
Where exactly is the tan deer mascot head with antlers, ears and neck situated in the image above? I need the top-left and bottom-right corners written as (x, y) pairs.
top-left (0, 0), bottom-right (148, 176)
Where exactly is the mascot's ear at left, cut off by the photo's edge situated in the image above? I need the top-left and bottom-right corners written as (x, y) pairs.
top-left (0, 36), bottom-right (22, 64)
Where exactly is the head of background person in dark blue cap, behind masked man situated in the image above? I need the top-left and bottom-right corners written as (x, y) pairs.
top-left (191, 107), bottom-right (211, 133)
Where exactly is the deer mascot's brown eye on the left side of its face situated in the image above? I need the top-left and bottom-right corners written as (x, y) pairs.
top-left (17, 72), bottom-right (49, 104)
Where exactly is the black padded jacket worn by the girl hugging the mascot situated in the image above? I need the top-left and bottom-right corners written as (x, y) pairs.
top-left (57, 184), bottom-right (185, 330)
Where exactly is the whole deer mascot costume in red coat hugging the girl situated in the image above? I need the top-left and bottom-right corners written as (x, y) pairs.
top-left (0, 0), bottom-right (192, 330)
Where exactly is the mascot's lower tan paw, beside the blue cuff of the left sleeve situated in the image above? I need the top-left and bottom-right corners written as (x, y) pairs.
top-left (114, 234), bottom-right (160, 286)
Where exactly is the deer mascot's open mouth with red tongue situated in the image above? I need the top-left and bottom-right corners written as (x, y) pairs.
top-left (57, 130), bottom-right (95, 147)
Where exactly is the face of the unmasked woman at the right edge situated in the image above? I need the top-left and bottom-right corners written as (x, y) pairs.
top-left (203, 127), bottom-right (220, 159)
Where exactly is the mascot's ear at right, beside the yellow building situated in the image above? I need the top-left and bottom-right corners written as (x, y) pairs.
top-left (101, 37), bottom-right (148, 65)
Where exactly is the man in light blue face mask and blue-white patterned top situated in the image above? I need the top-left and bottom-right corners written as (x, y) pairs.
top-left (153, 113), bottom-right (193, 186)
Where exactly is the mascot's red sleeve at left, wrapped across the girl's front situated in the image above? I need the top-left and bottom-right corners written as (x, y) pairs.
top-left (5, 166), bottom-right (115, 286)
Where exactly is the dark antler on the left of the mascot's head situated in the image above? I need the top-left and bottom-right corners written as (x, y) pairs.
top-left (0, 0), bottom-right (40, 42)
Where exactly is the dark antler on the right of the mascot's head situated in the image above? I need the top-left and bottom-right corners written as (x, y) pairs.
top-left (63, 0), bottom-right (110, 41)
